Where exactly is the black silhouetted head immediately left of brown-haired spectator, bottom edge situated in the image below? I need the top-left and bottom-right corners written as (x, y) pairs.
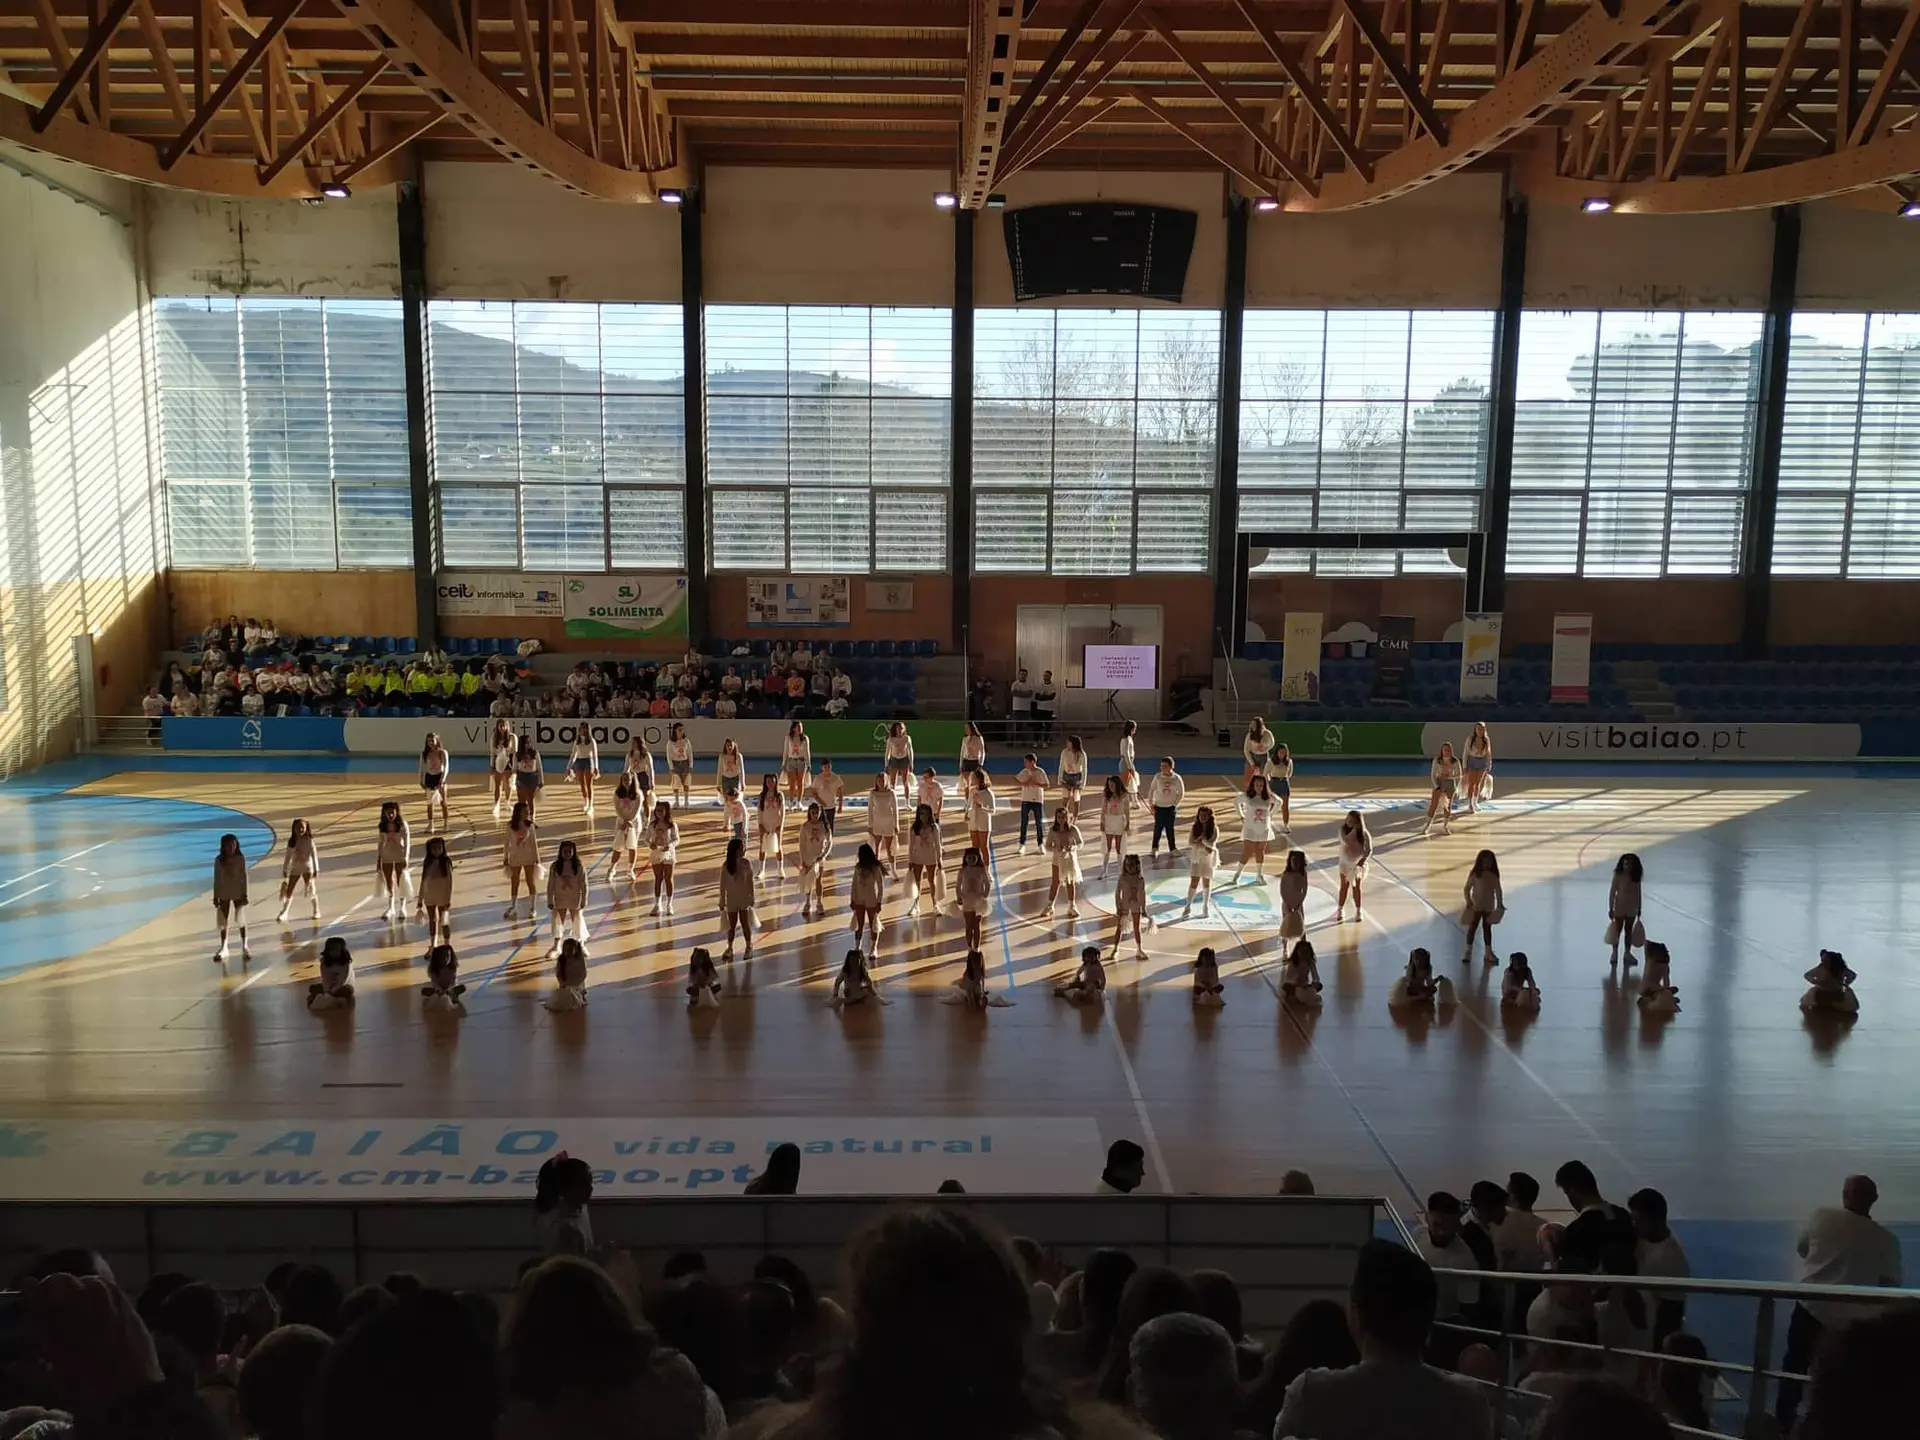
top-left (309, 1290), bottom-right (499, 1440)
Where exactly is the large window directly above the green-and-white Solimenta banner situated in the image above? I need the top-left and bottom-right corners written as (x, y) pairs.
top-left (426, 300), bottom-right (687, 570)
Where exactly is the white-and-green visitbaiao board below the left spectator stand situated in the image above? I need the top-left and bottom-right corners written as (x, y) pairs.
top-left (339, 714), bottom-right (966, 770)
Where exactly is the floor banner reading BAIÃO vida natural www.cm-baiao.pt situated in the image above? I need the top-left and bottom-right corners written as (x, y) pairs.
top-left (0, 1116), bottom-right (1104, 1204)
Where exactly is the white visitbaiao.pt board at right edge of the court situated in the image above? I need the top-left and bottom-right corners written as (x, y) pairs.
top-left (1421, 720), bottom-right (1860, 770)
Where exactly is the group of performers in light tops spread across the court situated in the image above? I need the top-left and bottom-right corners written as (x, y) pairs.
top-left (198, 720), bottom-right (1859, 1016)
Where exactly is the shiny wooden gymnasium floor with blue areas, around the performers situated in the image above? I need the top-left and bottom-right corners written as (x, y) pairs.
top-left (0, 756), bottom-right (1920, 1219)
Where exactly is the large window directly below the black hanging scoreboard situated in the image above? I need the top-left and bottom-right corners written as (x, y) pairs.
top-left (973, 309), bottom-right (1219, 576)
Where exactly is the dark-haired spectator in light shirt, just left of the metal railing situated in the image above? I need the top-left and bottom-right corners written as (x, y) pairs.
top-left (1273, 1240), bottom-right (1492, 1440)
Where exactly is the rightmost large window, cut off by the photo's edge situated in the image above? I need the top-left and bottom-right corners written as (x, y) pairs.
top-left (1774, 313), bottom-right (1920, 580)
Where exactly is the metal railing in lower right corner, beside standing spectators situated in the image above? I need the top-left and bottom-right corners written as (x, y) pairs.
top-left (1428, 1267), bottom-right (1920, 1440)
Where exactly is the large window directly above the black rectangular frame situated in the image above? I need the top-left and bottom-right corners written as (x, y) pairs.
top-left (1240, 309), bottom-right (1494, 574)
